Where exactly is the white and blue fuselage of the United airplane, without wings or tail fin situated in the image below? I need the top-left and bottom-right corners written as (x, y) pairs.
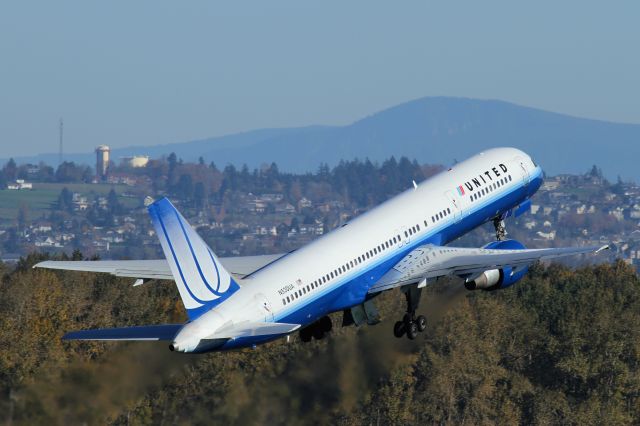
top-left (176, 148), bottom-right (542, 347)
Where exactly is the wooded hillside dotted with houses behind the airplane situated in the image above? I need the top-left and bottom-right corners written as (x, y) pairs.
top-left (0, 155), bottom-right (640, 265)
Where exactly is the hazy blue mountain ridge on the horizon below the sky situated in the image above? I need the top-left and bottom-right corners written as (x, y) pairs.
top-left (8, 97), bottom-right (640, 180)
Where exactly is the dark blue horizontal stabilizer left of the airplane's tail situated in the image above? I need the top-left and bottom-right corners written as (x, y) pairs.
top-left (62, 324), bottom-right (184, 340)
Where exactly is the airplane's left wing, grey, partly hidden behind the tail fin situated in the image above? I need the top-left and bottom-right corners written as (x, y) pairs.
top-left (34, 254), bottom-right (284, 280)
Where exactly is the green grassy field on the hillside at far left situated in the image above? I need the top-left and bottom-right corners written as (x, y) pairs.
top-left (0, 183), bottom-right (138, 224)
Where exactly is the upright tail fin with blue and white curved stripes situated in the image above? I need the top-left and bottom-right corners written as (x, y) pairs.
top-left (148, 198), bottom-right (240, 320)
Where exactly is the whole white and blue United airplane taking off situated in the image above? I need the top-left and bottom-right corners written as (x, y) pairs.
top-left (34, 148), bottom-right (608, 353)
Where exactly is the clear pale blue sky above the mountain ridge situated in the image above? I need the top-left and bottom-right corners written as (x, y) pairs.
top-left (0, 0), bottom-right (640, 158)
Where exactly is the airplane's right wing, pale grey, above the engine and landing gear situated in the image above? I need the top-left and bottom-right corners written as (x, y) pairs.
top-left (369, 245), bottom-right (609, 293)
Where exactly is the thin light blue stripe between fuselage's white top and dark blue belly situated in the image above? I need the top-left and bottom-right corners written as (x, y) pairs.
top-left (274, 171), bottom-right (542, 322)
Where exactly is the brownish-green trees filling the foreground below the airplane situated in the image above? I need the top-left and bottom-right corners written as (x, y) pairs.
top-left (0, 254), bottom-right (640, 425)
